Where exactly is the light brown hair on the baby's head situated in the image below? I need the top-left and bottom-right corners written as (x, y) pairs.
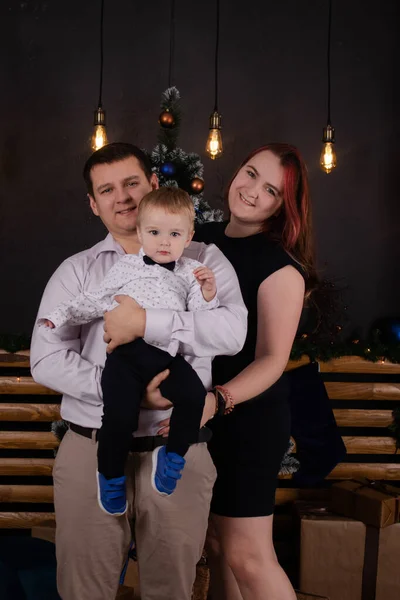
top-left (137, 187), bottom-right (195, 227)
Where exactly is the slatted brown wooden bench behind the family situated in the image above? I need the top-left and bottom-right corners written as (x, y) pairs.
top-left (0, 350), bottom-right (400, 529)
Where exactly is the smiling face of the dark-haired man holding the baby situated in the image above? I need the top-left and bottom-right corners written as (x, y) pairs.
top-left (89, 156), bottom-right (158, 238)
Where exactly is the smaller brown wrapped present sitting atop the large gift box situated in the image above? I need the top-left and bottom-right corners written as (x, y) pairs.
top-left (331, 478), bottom-right (400, 528)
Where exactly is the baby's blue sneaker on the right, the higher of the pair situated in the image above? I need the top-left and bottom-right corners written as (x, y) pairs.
top-left (151, 446), bottom-right (186, 496)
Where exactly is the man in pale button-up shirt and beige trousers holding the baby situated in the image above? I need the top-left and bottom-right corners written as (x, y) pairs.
top-left (31, 143), bottom-right (247, 600)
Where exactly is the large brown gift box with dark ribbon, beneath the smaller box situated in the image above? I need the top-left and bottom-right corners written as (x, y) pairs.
top-left (296, 503), bottom-right (400, 600)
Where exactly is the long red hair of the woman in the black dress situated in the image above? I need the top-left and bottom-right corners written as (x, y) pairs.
top-left (228, 142), bottom-right (316, 289)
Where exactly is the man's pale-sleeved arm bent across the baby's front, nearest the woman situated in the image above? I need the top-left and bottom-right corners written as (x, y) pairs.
top-left (144, 244), bottom-right (247, 357)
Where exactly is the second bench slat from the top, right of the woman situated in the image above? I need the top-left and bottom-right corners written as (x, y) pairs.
top-left (325, 381), bottom-right (400, 402)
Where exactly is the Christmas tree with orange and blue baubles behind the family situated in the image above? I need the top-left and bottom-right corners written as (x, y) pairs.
top-left (149, 87), bottom-right (223, 223)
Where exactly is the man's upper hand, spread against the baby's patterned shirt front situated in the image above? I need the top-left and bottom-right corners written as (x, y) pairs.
top-left (103, 296), bottom-right (146, 353)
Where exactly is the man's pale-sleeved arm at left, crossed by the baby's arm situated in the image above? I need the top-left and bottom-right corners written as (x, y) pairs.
top-left (31, 260), bottom-right (102, 405)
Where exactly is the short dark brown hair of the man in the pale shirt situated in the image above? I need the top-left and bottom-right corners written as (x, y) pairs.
top-left (83, 142), bottom-right (153, 196)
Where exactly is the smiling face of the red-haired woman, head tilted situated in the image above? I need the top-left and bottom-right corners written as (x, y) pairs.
top-left (228, 150), bottom-right (284, 225)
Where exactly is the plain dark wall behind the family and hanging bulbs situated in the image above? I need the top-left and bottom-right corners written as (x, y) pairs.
top-left (0, 0), bottom-right (400, 333)
